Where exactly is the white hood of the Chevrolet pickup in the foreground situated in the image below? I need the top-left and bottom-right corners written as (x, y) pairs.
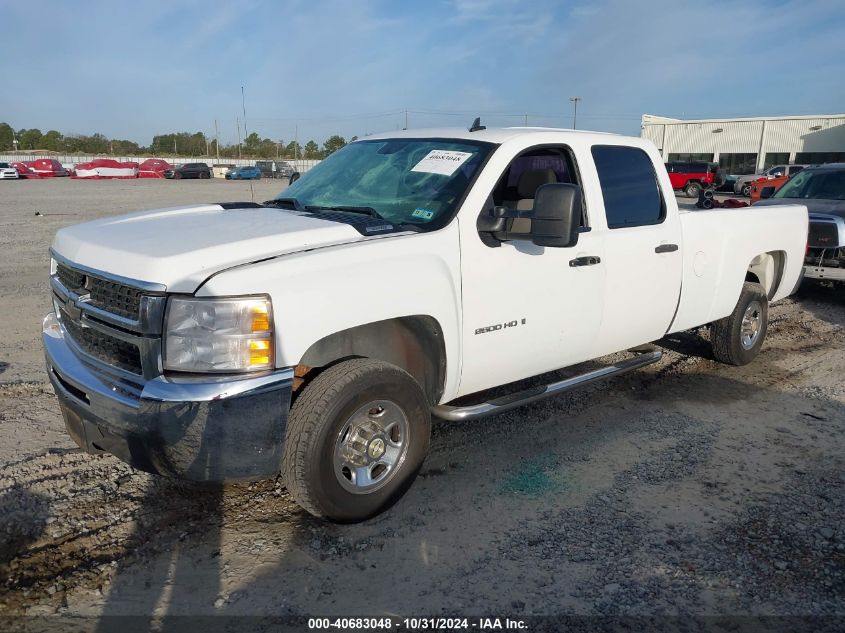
top-left (53, 204), bottom-right (366, 292)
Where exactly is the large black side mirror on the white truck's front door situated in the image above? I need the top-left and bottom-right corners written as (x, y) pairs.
top-left (531, 183), bottom-right (582, 248)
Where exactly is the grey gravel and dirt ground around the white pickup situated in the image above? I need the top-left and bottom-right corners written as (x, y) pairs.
top-left (0, 179), bottom-right (845, 616)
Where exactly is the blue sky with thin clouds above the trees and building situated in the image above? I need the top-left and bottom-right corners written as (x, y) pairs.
top-left (0, 0), bottom-right (845, 145)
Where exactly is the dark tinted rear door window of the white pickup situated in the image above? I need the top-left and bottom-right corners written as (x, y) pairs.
top-left (592, 145), bottom-right (666, 229)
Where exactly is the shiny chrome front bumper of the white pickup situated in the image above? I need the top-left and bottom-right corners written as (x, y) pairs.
top-left (42, 314), bottom-right (293, 481)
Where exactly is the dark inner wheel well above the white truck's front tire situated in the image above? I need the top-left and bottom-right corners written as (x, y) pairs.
top-left (297, 315), bottom-right (446, 405)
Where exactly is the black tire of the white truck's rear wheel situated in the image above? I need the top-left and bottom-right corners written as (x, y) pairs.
top-left (710, 281), bottom-right (769, 365)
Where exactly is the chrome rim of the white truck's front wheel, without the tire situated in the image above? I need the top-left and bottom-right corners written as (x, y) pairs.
top-left (334, 400), bottom-right (410, 494)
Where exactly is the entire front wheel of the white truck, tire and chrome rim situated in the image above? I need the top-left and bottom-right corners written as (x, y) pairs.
top-left (284, 358), bottom-right (431, 522)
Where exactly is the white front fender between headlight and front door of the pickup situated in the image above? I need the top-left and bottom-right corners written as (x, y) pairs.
top-left (196, 222), bottom-right (461, 400)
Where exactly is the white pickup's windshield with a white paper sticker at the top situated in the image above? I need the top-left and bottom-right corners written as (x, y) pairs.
top-left (278, 139), bottom-right (493, 228)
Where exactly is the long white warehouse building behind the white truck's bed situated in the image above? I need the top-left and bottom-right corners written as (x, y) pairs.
top-left (640, 114), bottom-right (845, 175)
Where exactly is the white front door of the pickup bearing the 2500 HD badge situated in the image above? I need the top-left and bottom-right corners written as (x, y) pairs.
top-left (459, 146), bottom-right (605, 395)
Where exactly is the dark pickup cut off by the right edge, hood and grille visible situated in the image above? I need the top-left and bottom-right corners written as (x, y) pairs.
top-left (754, 163), bottom-right (845, 282)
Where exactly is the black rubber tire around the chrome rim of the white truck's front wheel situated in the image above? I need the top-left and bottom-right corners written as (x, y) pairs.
top-left (283, 358), bottom-right (431, 523)
